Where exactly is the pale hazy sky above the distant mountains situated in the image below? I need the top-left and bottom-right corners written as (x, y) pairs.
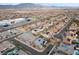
top-left (0, 3), bottom-right (79, 7)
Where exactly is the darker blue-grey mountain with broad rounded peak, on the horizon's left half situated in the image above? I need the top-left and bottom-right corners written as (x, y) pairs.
top-left (0, 3), bottom-right (45, 9)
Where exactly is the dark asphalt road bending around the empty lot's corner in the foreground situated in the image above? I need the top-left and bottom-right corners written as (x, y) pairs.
top-left (9, 38), bottom-right (53, 55)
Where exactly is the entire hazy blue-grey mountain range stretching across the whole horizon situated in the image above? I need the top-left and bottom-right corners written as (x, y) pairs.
top-left (0, 3), bottom-right (79, 9)
